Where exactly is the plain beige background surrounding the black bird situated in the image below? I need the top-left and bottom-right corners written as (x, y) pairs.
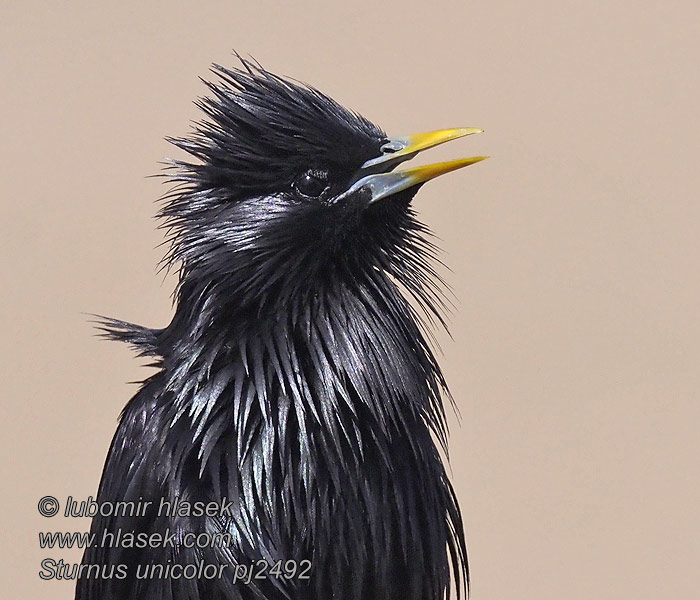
top-left (0, 0), bottom-right (700, 600)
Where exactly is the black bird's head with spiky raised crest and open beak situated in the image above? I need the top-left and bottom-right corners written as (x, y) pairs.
top-left (161, 59), bottom-right (485, 314)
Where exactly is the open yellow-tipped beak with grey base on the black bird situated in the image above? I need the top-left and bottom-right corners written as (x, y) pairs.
top-left (344, 127), bottom-right (488, 203)
